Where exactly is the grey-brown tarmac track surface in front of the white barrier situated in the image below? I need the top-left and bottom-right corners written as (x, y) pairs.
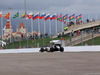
top-left (0, 52), bottom-right (100, 75)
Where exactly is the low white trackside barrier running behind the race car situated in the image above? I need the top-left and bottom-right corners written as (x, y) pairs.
top-left (0, 46), bottom-right (100, 53)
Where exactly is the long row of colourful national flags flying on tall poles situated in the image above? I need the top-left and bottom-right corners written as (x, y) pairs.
top-left (0, 12), bottom-right (82, 22)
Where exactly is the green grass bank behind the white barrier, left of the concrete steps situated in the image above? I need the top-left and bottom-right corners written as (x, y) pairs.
top-left (4, 36), bottom-right (69, 49)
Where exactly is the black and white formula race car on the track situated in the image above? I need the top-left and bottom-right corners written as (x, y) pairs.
top-left (40, 40), bottom-right (64, 52)
